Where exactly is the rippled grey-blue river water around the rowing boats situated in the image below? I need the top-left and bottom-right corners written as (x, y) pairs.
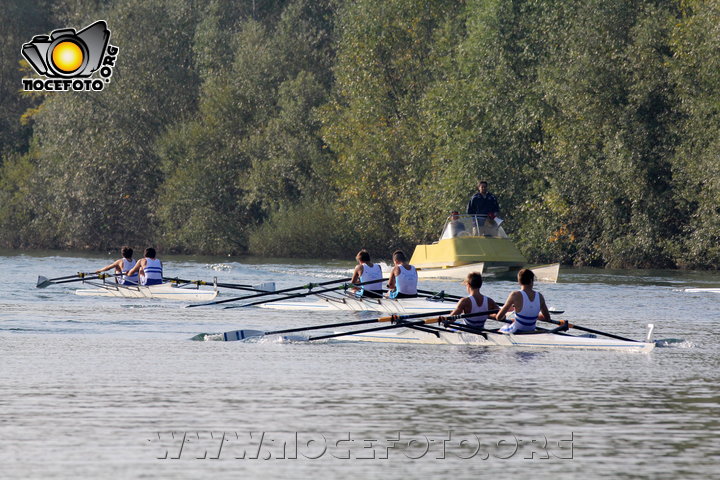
top-left (0, 251), bottom-right (720, 479)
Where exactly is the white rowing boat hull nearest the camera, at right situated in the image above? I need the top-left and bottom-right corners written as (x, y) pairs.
top-left (337, 328), bottom-right (655, 353)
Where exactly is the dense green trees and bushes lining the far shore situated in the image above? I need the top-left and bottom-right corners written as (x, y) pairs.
top-left (0, 0), bottom-right (720, 269)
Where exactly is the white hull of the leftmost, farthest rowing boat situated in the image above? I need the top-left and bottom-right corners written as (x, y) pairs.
top-left (75, 282), bottom-right (218, 302)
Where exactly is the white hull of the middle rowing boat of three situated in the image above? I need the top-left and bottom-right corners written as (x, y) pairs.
top-left (258, 296), bottom-right (457, 313)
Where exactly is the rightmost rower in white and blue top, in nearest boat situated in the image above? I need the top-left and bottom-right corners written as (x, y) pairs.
top-left (497, 268), bottom-right (550, 333)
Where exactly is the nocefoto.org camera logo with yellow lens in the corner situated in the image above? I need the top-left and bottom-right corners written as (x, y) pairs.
top-left (21, 20), bottom-right (119, 92)
